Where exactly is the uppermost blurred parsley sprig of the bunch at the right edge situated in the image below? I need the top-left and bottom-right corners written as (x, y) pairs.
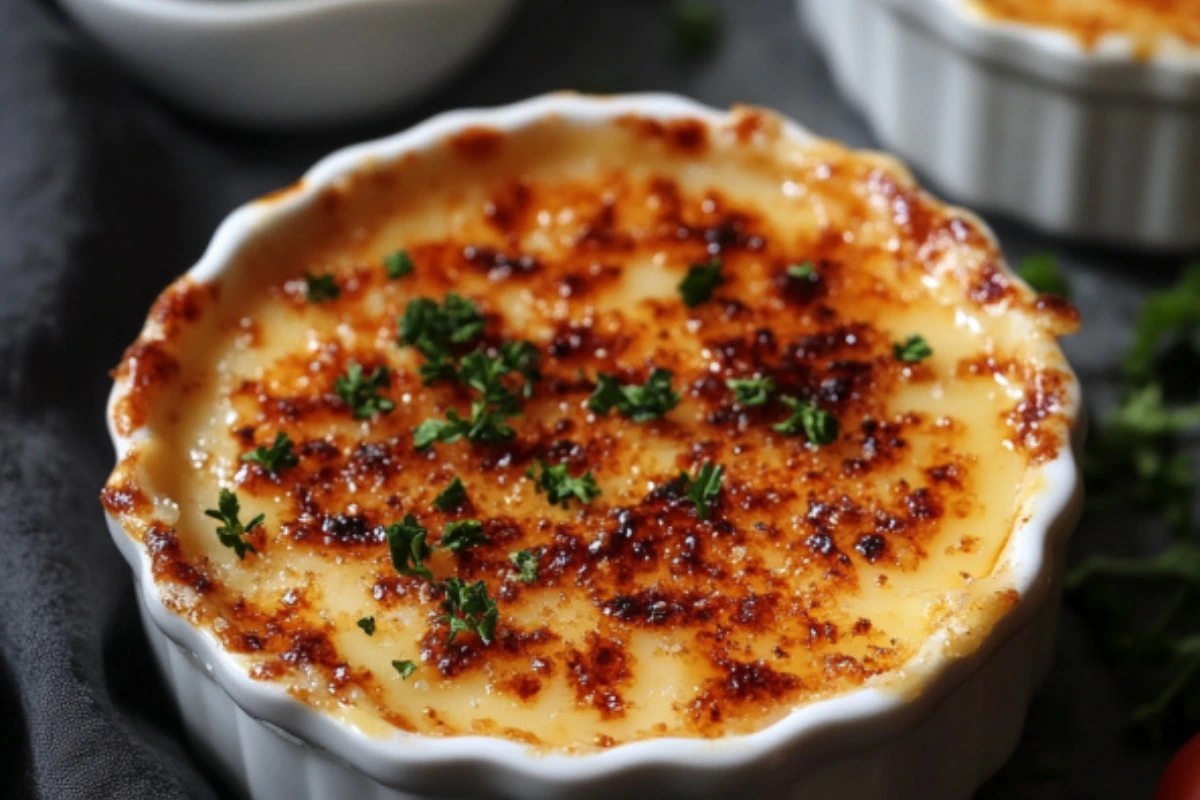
top-left (1123, 264), bottom-right (1200, 385)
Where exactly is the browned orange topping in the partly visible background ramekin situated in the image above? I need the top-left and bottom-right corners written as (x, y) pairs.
top-left (972, 0), bottom-right (1200, 55)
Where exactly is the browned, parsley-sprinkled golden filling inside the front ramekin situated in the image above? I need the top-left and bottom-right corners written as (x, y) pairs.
top-left (102, 109), bottom-right (1076, 752)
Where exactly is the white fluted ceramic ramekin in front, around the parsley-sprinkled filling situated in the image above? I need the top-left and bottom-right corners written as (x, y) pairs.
top-left (108, 95), bottom-right (1080, 800)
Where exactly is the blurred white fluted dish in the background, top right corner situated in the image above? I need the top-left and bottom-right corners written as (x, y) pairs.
top-left (798, 0), bottom-right (1200, 249)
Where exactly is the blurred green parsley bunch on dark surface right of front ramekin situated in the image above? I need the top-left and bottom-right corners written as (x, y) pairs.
top-left (1056, 264), bottom-right (1200, 739)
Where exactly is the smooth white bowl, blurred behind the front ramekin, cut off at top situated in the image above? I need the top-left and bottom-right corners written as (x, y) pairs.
top-left (61, 0), bottom-right (517, 128)
